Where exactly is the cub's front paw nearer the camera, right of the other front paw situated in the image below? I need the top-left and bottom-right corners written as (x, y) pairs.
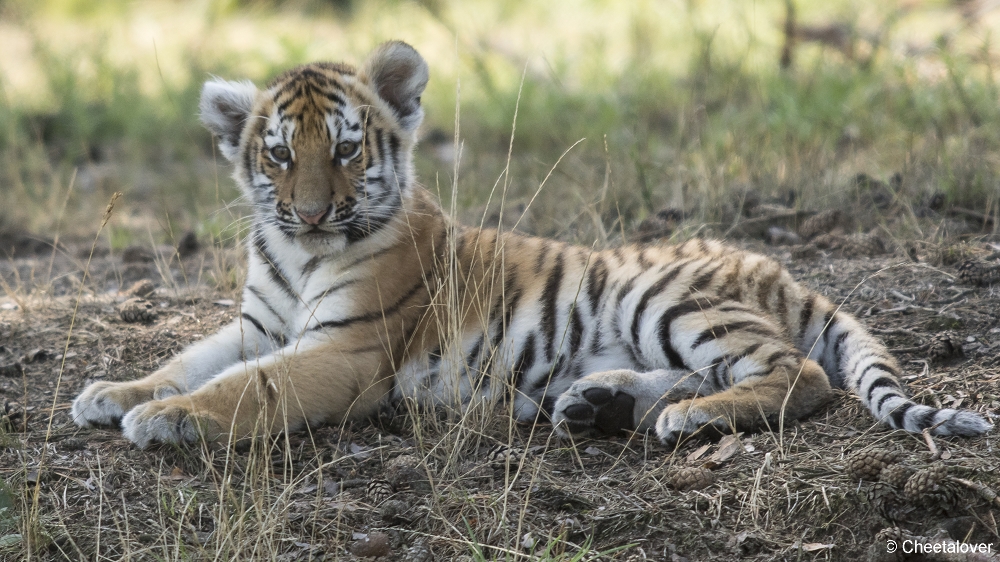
top-left (122, 399), bottom-right (219, 449)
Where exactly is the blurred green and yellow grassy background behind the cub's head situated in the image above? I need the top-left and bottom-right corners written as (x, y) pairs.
top-left (0, 0), bottom-right (1000, 247)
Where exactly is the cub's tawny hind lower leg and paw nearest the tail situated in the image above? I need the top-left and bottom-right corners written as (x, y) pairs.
top-left (656, 355), bottom-right (830, 445)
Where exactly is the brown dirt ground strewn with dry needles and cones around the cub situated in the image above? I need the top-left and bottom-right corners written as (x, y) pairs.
top-left (0, 209), bottom-right (1000, 561)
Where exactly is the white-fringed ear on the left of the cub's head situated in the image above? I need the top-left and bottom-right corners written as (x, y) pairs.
top-left (199, 78), bottom-right (257, 161)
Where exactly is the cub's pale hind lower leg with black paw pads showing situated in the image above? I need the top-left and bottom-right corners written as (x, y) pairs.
top-left (552, 369), bottom-right (716, 436)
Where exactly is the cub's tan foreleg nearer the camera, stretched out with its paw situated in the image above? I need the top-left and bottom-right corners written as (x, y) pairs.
top-left (122, 338), bottom-right (392, 448)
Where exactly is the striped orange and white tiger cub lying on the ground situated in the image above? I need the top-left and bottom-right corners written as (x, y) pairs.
top-left (72, 42), bottom-right (992, 447)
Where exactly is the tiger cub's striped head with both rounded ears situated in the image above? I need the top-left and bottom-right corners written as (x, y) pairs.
top-left (201, 41), bottom-right (428, 255)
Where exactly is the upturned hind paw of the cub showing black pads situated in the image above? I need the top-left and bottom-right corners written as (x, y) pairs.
top-left (553, 379), bottom-right (635, 436)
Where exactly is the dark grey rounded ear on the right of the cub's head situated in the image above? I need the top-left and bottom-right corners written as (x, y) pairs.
top-left (361, 41), bottom-right (429, 131)
